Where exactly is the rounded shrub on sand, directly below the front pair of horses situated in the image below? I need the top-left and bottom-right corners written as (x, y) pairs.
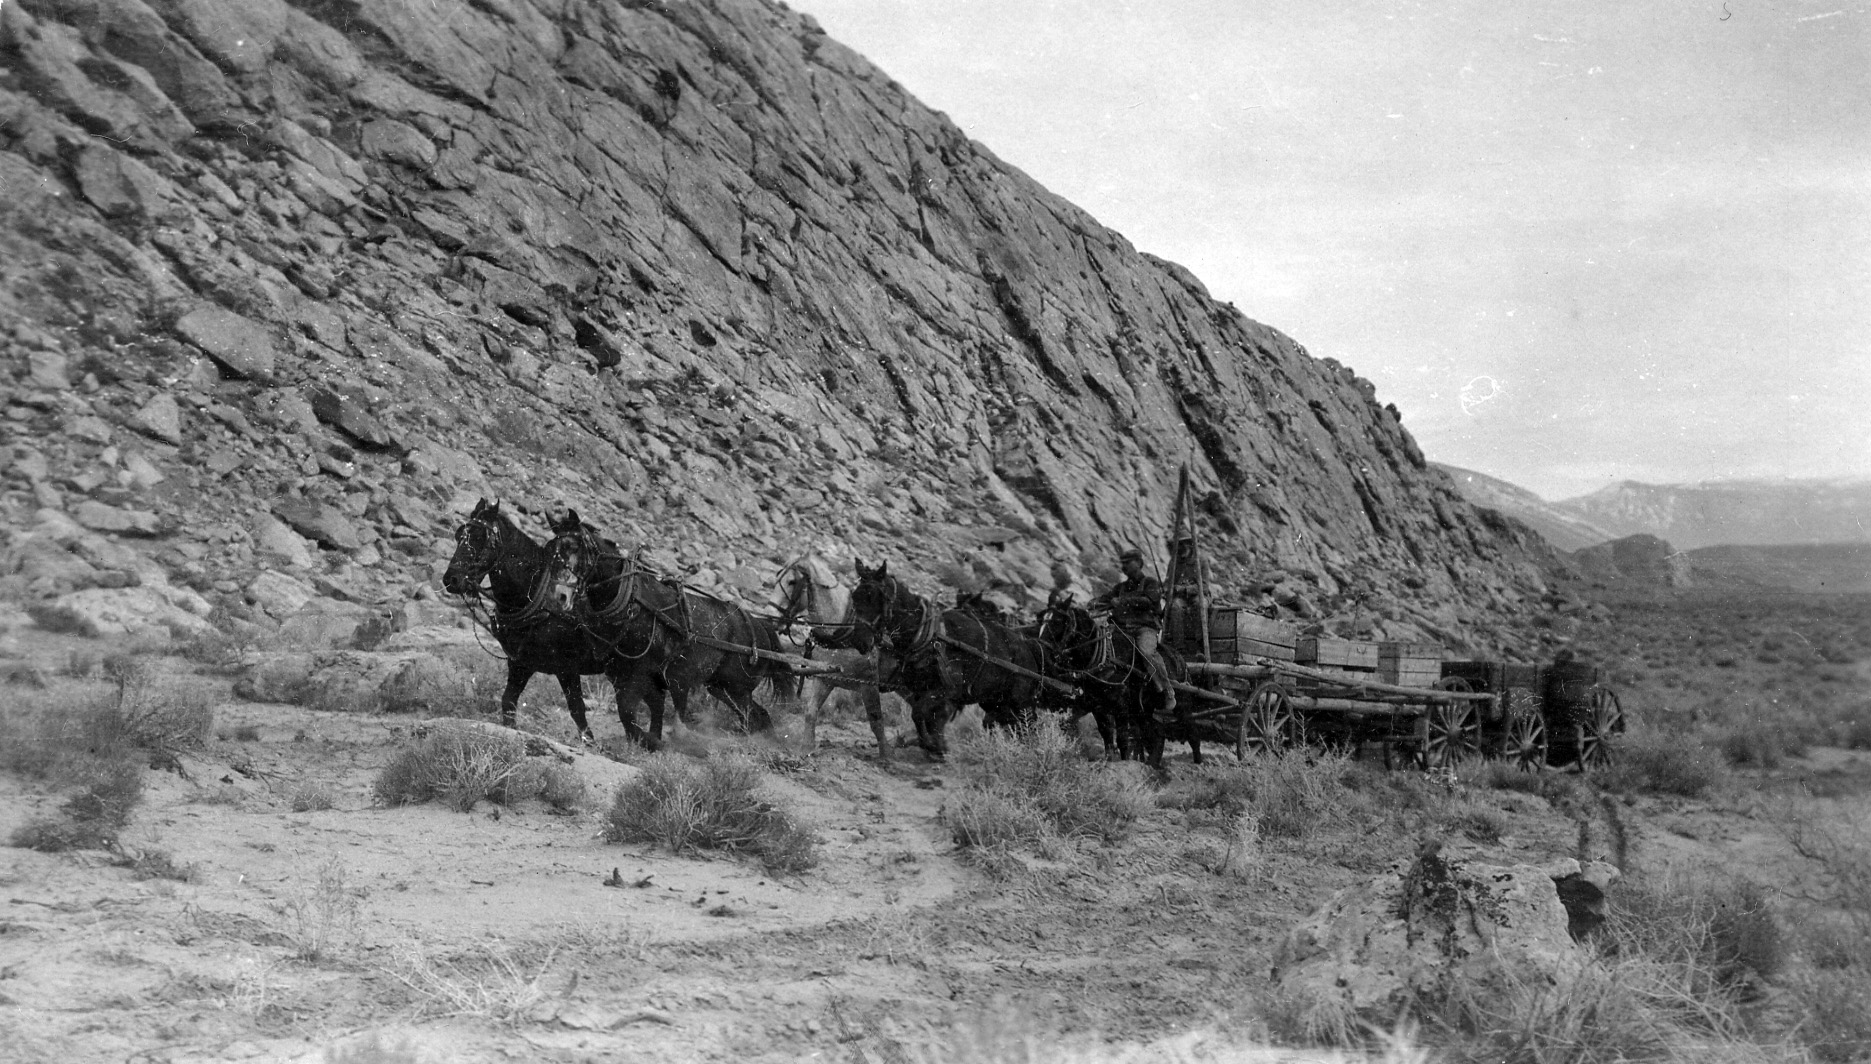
top-left (604, 754), bottom-right (818, 871)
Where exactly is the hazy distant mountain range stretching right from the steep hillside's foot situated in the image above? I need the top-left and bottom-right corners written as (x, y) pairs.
top-left (1439, 466), bottom-right (1871, 552)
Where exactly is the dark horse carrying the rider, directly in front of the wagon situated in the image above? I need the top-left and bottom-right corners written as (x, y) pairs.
top-left (1038, 591), bottom-right (1177, 769)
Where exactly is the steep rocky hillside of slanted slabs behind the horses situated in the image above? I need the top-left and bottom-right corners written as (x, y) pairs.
top-left (0, 0), bottom-right (1545, 645)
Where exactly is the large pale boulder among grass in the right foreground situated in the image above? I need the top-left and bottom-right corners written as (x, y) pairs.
top-left (1274, 847), bottom-right (1594, 1030)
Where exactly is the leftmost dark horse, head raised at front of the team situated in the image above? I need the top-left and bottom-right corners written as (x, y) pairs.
top-left (442, 499), bottom-right (662, 742)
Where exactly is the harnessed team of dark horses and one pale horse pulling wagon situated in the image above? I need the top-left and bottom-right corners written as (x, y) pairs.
top-left (442, 499), bottom-right (1199, 767)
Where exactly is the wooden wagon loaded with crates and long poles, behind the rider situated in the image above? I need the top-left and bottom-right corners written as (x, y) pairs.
top-left (1166, 604), bottom-right (1624, 770)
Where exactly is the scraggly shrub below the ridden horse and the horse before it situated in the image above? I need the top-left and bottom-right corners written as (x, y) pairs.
top-left (943, 722), bottom-right (1156, 845)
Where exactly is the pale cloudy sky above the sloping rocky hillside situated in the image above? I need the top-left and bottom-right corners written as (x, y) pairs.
top-left (791, 0), bottom-right (1871, 499)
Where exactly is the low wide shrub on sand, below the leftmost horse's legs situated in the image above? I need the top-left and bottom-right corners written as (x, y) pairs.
top-left (362, 727), bottom-right (568, 812)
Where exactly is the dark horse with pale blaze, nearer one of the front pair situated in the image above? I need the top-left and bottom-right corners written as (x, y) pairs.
top-left (546, 512), bottom-right (797, 748)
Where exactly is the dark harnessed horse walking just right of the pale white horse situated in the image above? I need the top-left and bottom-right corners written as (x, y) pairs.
top-left (846, 563), bottom-right (1046, 757)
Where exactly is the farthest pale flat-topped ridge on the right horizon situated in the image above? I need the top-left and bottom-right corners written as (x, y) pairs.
top-left (1553, 481), bottom-right (1871, 550)
